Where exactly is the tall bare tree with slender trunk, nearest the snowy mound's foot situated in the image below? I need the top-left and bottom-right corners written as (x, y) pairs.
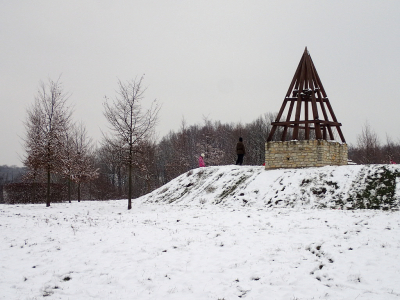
top-left (104, 77), bottom-right (160, 209)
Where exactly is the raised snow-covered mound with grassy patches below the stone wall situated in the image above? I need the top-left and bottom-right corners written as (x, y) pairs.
top-left (140, 165), bottom-right (400, 209)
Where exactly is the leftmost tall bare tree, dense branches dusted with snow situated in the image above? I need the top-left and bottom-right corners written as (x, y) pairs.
top-left (24, 80), bottom-right (72, 206)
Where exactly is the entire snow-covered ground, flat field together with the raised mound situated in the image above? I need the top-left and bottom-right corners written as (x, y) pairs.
top-left (0, 165), bottom-right (400, 300)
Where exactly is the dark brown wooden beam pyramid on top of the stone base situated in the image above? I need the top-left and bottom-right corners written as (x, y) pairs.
top-left (267, 47), bottom-right (346, 143)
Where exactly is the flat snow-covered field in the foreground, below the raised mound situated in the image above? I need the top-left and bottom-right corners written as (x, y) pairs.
top-left (0, 200), bottom-right (400, 300)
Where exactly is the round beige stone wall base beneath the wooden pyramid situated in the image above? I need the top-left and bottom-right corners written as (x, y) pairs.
top-left (265, 140), bottom-right (347, 169)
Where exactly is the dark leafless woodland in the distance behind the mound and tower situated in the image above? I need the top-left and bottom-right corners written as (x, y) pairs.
top-left (0, 118), bottom-right (400, 200)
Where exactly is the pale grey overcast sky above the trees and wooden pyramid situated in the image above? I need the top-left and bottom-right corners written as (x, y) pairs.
top-left (0, 0), bottom-right (400, 166)
